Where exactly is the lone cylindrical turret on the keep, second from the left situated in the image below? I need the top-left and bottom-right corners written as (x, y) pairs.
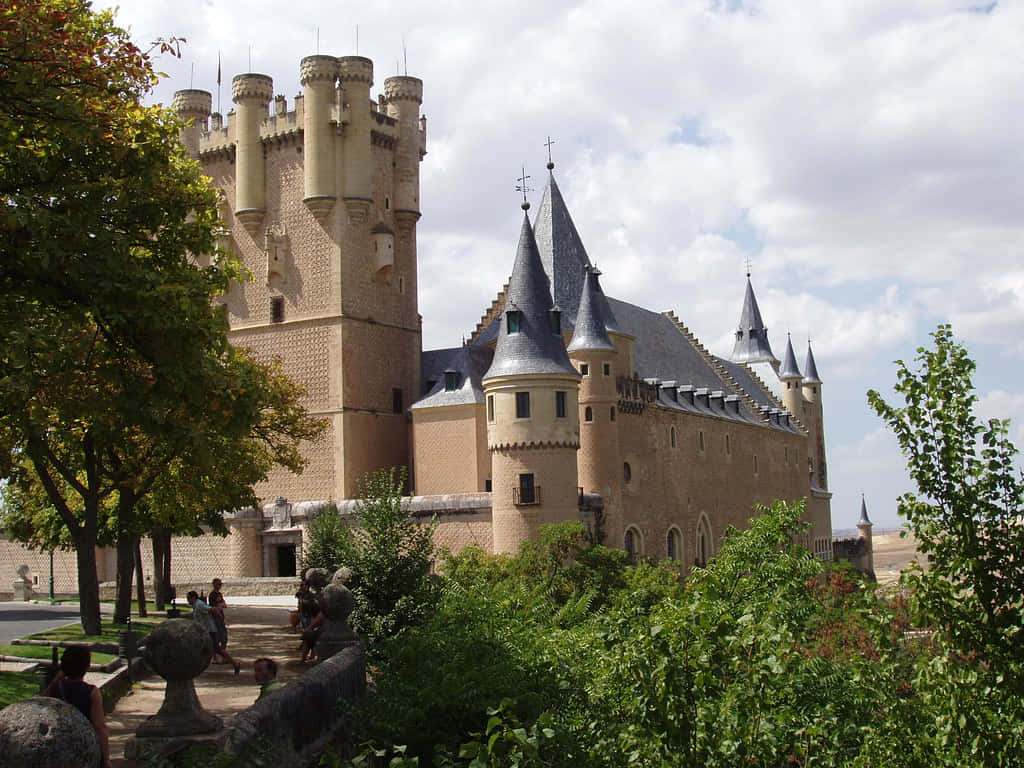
top-left (231, 73), bottom-right (273, 232)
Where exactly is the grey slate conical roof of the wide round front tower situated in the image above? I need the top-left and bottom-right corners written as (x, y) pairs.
top-left (483, 214), bottom-right (579, 380)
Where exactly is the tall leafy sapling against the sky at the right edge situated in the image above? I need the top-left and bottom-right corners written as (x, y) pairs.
top-left (867, 326), bottom-right (1024, 671)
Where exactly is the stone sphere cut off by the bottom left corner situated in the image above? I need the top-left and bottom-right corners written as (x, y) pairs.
top-left (0, 696), bottom-right (100, 768)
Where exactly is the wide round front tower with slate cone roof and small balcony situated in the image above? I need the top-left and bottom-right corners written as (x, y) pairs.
top-left (482, 203), bottom-right (580, 552)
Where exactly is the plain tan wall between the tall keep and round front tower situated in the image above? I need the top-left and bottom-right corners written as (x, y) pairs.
top-left (413, 404), bottom-right (490, 495)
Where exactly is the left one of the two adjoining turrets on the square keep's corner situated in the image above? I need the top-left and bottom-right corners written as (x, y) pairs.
top-left (300, 55), bottom-right (338, 218)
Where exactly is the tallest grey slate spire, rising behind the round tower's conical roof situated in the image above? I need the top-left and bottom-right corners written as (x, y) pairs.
top-left (534, 172), bottom-right (608, 327)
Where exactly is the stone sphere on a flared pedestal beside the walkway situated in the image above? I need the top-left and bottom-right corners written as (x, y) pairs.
top-left (135, 618), bottom-right (222, 737)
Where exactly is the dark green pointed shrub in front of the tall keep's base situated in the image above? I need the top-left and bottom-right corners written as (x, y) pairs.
top-left (340, 467), bottom-right (438, 649)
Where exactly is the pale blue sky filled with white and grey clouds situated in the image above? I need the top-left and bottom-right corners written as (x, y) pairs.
top-left (99, 0), bottom-right (1024, 528)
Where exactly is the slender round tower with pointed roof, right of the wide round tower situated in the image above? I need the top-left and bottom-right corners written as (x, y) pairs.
top-left (567, 267), bottom-right (622, 544)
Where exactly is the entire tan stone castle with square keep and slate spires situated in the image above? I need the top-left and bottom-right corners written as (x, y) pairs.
top-left (4, 55), bottom-right (869, 593)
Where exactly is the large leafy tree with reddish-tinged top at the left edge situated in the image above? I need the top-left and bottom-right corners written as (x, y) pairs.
top-left (0, 0), bottom-right (318, 634)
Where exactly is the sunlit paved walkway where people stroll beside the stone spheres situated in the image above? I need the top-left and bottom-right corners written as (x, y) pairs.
top-left (108, 595), bottom-right (309, 766)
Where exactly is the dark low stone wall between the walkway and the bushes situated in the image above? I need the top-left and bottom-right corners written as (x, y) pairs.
top-left (220, 644), bottom-right (367, 768)
